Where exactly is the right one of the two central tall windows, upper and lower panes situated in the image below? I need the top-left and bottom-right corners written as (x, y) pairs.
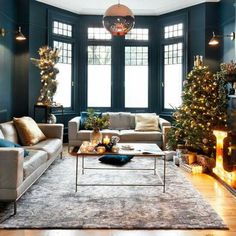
top-left (125, 29), bottom-right (148, 108)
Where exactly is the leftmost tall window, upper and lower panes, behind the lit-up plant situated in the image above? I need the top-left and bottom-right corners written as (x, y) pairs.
top-left (52, 21), bottom-right (73, 107)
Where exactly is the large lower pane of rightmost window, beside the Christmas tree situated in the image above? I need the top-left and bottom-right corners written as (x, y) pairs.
top-left (164, 43), bottom-right (183, 109)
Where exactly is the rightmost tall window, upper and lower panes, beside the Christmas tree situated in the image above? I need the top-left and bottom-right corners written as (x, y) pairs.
top-left (163, 23), bottom-right (183, 109)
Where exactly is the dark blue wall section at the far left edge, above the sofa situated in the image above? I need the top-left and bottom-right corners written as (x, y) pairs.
top-left (0, 0), bottom-right (16, 122)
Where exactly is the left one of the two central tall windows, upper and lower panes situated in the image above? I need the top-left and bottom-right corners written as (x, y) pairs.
top-left (87, 28), bottom-right (111, 107)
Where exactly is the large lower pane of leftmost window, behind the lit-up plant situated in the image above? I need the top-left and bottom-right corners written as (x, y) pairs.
top-left (53, 41), bottom-right (72, 107)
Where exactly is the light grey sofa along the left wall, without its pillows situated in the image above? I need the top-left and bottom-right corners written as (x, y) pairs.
top-left (0, 121), bottom-right (63, 214)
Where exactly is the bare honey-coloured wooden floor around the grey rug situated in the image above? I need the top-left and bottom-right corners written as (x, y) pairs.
top-left (0, 148), bottom-right (236, 236)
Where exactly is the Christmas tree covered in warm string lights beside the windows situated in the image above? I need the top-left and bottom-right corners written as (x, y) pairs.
top-left (168, 57), bottom-right (227, 155)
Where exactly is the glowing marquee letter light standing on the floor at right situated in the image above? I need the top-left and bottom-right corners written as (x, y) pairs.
top-left (213, 130), bottom-right (236, 186)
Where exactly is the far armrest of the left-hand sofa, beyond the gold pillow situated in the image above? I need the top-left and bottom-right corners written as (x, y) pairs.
top-left (38, 124), bottom-right (64, 140)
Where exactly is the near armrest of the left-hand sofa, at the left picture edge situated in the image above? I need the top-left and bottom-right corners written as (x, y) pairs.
top-left (0, 148), bottom-right (24, 191)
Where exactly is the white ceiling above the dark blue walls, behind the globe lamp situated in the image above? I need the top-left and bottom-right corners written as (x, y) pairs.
top-left (37, 0), bottom-right (220, 17)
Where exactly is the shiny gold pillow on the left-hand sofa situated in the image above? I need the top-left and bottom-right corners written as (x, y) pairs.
top-left (13, 116), bottom-right (46, 146)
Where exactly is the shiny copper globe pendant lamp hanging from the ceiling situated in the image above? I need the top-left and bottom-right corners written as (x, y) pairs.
top-left (103, 2), bottom-right (135, 36)
